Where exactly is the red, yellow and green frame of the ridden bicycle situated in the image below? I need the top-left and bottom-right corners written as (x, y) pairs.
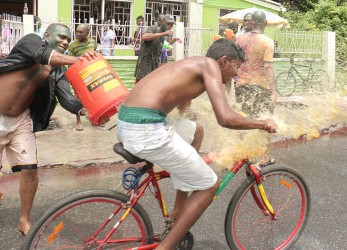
top-left (78, 157), bottom-right (275, 250)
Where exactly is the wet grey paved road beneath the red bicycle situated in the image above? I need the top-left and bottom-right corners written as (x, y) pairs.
top-left (0, 131), bottom-right (347, 250)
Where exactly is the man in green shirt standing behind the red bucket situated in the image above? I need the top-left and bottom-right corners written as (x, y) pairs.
top-left (68, 24), bottom-right (97, 131)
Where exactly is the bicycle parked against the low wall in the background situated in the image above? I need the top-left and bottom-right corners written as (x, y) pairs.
top-left (276, 56), bottom-right (330, 96)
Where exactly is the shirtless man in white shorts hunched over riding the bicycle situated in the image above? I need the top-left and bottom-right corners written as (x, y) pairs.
top-left (117, 39), bottom-right (276, 250)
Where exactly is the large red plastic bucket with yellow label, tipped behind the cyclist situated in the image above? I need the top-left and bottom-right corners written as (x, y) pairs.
top-left (66, 54), bottom-right (128, 125)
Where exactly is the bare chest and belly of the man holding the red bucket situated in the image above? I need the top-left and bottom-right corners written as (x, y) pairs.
top-left (0, 64), bottom-right (51, 116)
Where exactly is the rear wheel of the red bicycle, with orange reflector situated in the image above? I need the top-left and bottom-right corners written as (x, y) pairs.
top-left (22, 190), bottom-right (153, 250)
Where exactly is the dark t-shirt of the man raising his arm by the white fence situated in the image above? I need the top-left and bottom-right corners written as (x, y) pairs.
top-left (135, 25), bottom-right (164, 79)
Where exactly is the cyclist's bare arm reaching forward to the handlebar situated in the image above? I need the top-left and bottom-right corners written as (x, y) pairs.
top-left (202, 58), bottom-right (276, 132)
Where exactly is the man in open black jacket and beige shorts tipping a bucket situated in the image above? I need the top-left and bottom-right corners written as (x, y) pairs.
top-left (0, 24), bottom-right (95, 235)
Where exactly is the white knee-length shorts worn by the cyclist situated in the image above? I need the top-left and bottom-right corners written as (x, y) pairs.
top-left (117, 121), bottom-right (218, 192)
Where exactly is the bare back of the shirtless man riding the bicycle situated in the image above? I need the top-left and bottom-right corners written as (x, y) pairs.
top-left (124, 57), bottom-right (226, 113)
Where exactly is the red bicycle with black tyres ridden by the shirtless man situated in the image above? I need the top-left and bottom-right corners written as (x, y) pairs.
top-left (23, 143), bottom-right (311, 250)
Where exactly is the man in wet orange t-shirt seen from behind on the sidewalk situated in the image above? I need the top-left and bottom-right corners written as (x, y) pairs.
top-left (235, 11), bottom-right (277, 165)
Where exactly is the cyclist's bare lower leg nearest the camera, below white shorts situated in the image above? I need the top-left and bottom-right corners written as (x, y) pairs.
top-left (156, 181), bottom-right (219, 250)
